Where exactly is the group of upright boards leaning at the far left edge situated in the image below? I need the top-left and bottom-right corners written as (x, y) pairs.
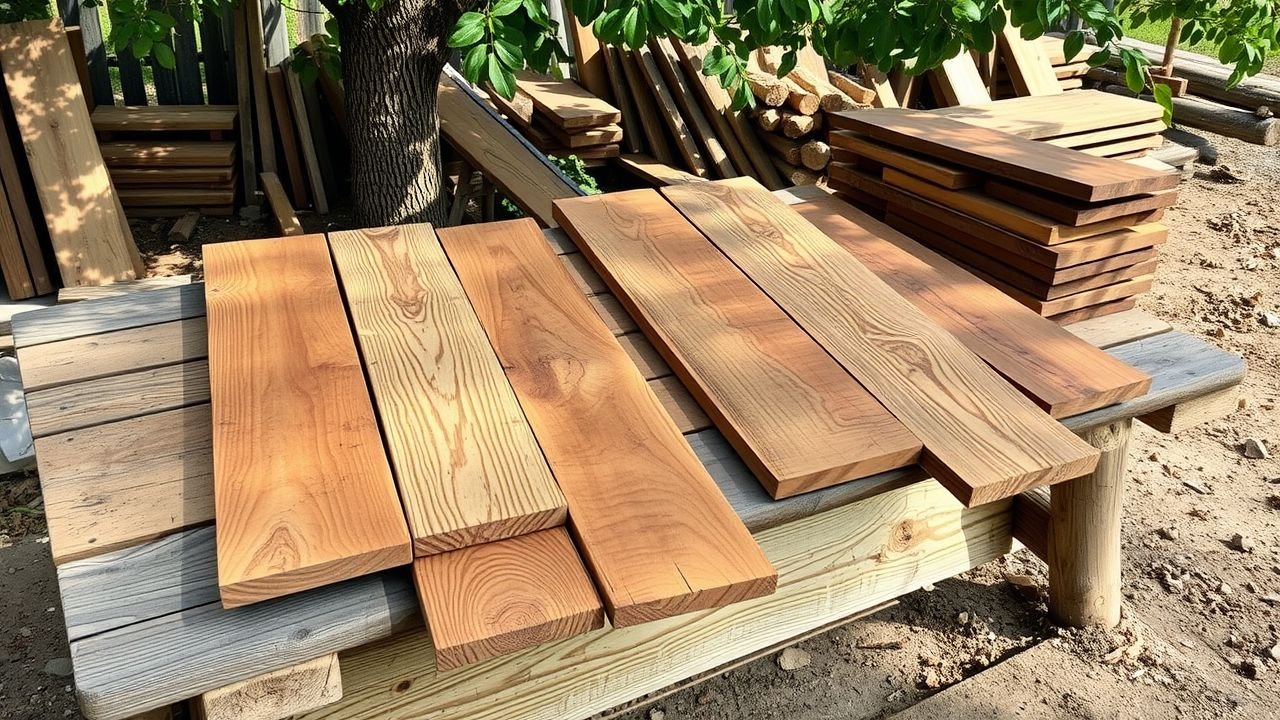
top-left (0, 20), bottom-right (146, 300)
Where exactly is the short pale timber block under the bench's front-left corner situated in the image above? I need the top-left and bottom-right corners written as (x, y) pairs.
top-left (191, 653), bottom-right (342, 720)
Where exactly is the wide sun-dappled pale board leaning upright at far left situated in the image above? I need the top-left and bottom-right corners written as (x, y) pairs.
top-left (0, 19), bottom-right (146, 286)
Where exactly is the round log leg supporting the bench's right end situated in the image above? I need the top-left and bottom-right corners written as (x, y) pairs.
top-left (1048, 420), bottom-right (1133, 628)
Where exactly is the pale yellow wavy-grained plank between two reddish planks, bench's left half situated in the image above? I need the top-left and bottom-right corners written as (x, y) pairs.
top-left (329, 225), bottom-right (564, 557)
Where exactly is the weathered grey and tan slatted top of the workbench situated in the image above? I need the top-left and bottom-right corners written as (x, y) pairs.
top-left (14, 231), bottom-right (1245, 717)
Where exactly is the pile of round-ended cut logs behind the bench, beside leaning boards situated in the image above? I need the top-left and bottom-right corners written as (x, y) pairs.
top-left (748, 47), bottom-right (876, 184)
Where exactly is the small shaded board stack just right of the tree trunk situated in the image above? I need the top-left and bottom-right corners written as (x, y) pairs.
top-left (489, 70), bottom-right (623, 167)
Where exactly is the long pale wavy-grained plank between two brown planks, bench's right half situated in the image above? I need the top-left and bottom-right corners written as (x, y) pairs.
top-left (662, 181), bottom-right (1098, 506)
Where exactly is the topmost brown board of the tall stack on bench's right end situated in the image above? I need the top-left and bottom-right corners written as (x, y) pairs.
top-left (828, 110), bottom-right (1179, 201)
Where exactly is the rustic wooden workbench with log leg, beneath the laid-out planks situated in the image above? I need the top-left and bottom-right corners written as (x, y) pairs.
top-left (14, 220), bottom-right (1244, 720)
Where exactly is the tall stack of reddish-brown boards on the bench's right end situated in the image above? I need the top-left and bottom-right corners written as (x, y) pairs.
top-left (828, 110), bottom-right (1179, 324)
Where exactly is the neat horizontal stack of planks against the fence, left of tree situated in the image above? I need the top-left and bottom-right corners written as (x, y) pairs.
top-left (92, 105), bottom-right (238, 217)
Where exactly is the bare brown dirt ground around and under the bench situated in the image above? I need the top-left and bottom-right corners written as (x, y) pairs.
top-left (0, 130), bottom-right (1280, 720)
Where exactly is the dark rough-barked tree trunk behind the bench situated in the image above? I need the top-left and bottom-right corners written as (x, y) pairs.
top-left (330, 0), bottom-right (471, 227)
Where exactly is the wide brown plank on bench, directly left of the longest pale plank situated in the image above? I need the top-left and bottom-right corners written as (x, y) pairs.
top-left (556, 190), bottom-right (920, 497)
